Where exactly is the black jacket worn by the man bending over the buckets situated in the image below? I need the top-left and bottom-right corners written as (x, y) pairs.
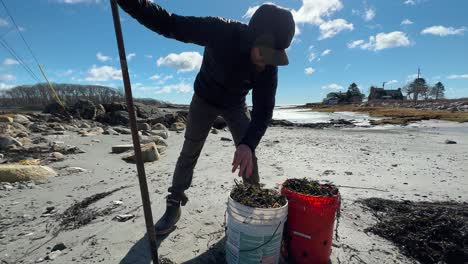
top-left (118, 0), bottom-right (278, 150)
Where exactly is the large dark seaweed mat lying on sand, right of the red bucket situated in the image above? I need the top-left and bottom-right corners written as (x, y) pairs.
top-left (360, 198), bottom-right (468, 264)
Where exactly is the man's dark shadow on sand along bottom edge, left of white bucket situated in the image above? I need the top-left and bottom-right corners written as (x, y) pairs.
top-left (120, 234), bottom-right (226, 264)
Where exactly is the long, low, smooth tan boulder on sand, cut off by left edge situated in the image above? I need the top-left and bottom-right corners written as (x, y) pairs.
top-left (0, 164), bottom-right (57, 183)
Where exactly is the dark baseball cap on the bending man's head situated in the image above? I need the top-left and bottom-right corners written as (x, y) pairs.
top-left (249, 4), bottom-right (296, 65)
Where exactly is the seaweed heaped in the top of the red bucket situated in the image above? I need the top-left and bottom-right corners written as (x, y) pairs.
top-left (283, 178), bottom-right (338, 196)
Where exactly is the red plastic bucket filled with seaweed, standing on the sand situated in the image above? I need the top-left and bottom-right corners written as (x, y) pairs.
top-left (281, 185), bottom-right (340, 264)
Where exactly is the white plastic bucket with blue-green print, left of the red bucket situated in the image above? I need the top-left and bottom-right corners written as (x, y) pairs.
top-left (226, 197), bottom-right (288, 264)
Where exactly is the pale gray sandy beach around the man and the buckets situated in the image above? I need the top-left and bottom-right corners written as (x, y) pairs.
top-left (0, 116), bottom-right (468, 264)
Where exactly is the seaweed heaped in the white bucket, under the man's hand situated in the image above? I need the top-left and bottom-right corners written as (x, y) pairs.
top-left (231, 183), bottom-right (286, 208)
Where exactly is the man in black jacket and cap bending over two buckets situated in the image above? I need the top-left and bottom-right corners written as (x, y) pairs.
top-left (118, 0), bottom-right (295, 235)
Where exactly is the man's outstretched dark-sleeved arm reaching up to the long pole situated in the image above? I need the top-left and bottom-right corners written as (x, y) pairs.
top-left (118, 0), bottom-right (238, 46)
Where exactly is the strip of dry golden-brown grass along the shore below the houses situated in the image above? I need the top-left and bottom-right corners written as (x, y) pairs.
top-left (311, 105), bottom-right (468, 125)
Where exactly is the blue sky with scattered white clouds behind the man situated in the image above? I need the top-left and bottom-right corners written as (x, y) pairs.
top-left (0, 0), bottom-right (468, 104)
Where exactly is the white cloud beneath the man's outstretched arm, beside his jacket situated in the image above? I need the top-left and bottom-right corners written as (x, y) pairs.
top-left (156, 51), bottom-right (203, 72)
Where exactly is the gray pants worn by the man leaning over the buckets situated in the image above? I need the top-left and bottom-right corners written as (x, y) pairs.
top-left (169, 95), bottom-right (260, 201)
